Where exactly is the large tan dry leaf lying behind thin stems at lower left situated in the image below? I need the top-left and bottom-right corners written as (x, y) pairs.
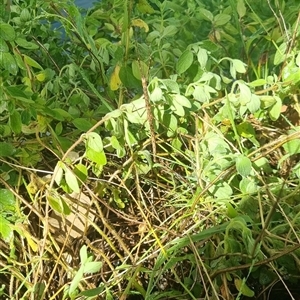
top-left (49, 192), bottom-right (95, 240)
